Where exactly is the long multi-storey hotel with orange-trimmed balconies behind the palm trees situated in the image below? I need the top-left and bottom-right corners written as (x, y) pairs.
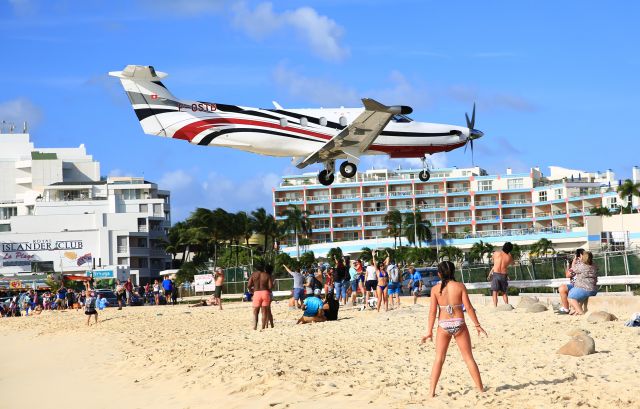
top-left (273, 166), bottom-right (640, 254)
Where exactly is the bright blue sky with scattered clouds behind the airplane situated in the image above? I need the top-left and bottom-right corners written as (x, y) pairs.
top-left (0, 0), bottom-right (640, 221)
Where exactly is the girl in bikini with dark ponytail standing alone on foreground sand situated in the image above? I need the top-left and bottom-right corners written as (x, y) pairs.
top-left (422, 261), bottom-right (487, 397)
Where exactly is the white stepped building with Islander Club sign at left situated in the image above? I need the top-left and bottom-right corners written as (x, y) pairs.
top-left (0, 134), bottom-right (171, 281)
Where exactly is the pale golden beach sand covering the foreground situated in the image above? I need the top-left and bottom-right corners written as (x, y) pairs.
top-left (0, 299), bottom-right (640, 409)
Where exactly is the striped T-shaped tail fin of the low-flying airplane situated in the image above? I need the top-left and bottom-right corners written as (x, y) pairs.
top-left (109, 65), bottom-right (180, 137)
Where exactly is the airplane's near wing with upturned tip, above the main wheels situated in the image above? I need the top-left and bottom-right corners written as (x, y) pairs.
top-left (296, 98), bottom-right (404, 169)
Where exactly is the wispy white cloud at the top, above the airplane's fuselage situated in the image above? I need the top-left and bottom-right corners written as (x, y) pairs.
top-left (232, 2), bottom-right (349, 61)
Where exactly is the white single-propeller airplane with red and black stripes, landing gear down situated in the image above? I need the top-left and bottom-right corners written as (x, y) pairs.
top-left (109, 65), bottom-right (484, 186)
